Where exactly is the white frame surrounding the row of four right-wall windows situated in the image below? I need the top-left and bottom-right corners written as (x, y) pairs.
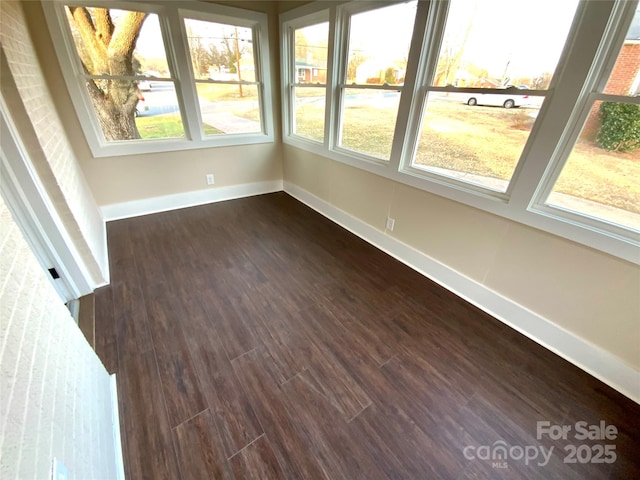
top-left (280, 0), bottom-right (640, 264)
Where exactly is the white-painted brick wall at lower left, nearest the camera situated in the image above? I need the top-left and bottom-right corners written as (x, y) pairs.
top-left (0, 197), bottom-right (116, 480)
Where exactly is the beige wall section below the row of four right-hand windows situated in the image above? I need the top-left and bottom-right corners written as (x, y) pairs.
top-left (283, 145), bottom-right (640, 370)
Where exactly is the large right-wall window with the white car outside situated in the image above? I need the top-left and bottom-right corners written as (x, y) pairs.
top-left (410, 0), bottom-right (578, 192)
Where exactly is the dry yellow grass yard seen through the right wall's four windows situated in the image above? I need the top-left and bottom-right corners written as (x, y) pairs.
top-left (296, 100), bottom-right (640, 214)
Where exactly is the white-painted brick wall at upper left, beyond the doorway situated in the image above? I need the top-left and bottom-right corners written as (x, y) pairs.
top-left (0, 0), bottom-right (108, 284)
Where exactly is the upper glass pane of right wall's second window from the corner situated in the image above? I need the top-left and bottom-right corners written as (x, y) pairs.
top-left (347, 2), bottom-right (417, 85)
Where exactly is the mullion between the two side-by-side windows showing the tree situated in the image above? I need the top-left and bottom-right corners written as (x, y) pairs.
top-left (165, 9), bottom-right (204, 141)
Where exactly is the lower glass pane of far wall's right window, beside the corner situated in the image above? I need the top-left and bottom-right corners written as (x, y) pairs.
top-left (196, 83), bottom-right (262, 135)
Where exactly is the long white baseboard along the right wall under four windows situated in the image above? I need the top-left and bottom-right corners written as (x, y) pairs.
top-left (284, 182), bottom-right (640, 403)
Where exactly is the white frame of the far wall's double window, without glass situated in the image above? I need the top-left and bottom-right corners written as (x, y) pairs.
top-left (42, 0), bottom-right (275, 157)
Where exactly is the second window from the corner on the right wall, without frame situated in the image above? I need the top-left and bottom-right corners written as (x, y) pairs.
top-left (337, 2), bottom-right (417, 160)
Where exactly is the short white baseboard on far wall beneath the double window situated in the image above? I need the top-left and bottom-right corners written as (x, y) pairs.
top-left (100, 180), bottom-right (283, 222)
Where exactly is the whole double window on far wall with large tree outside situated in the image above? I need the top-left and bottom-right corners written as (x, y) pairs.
top-left (43, 0), bottom-right (273, 157)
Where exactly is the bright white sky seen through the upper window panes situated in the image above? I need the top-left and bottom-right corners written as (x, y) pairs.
top-left (114, 0), bottom-right (578, 78)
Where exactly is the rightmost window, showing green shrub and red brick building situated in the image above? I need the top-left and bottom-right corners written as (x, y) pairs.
top-left (545, 4), bottom-right (640, 231)
